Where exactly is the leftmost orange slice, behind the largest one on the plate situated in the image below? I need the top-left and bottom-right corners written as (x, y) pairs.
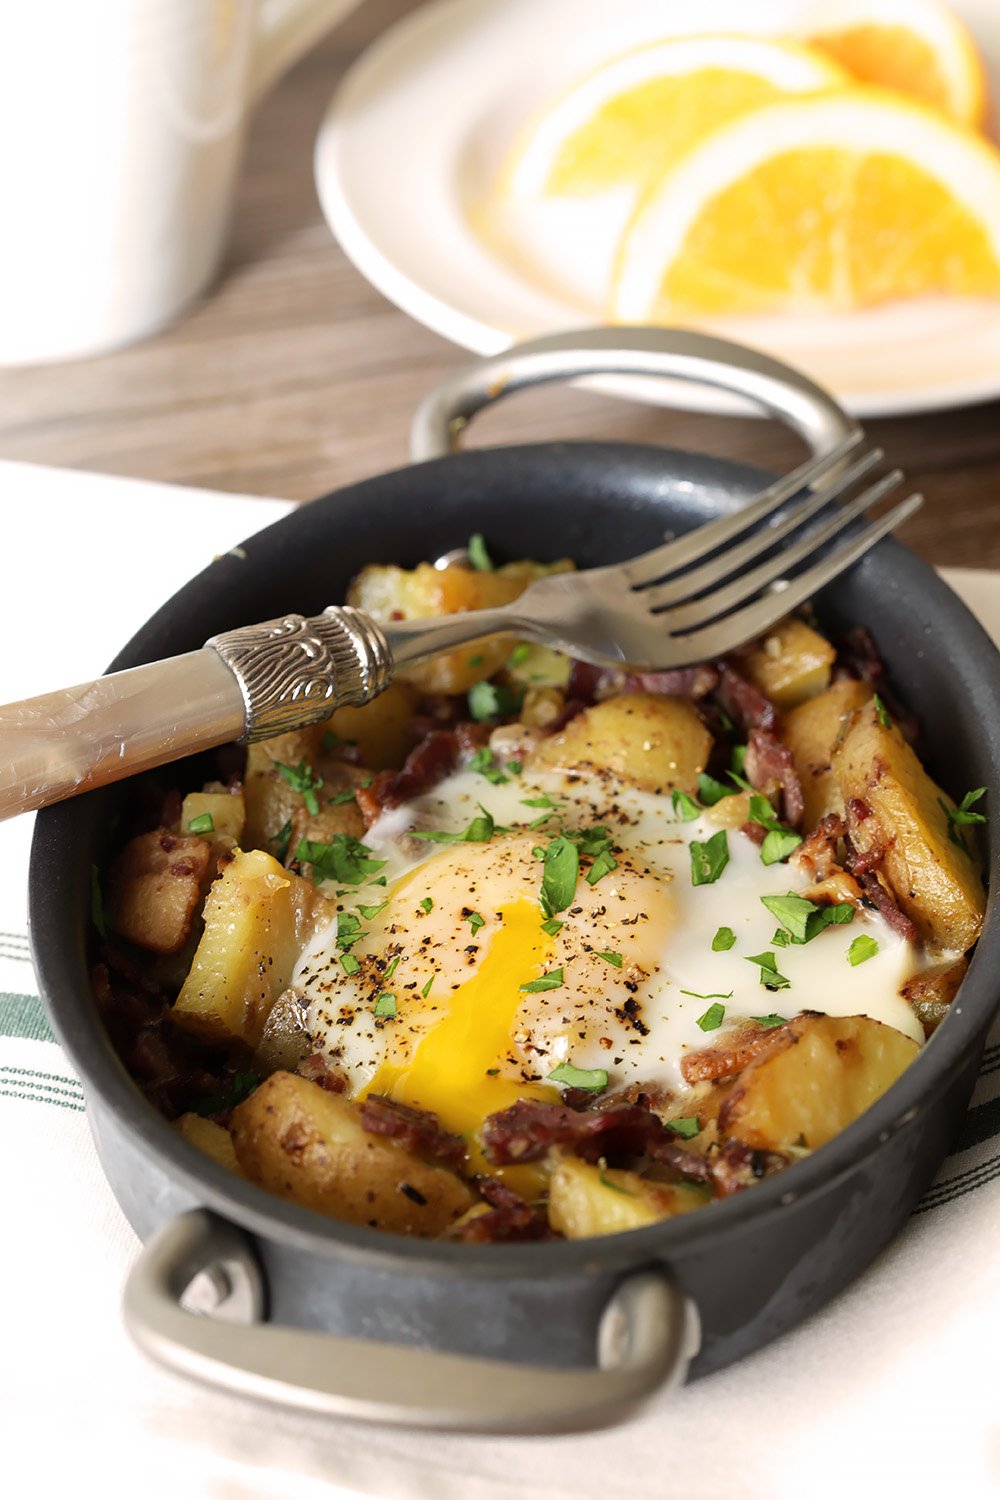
top-left (498, 35), bottom-right (846, 203)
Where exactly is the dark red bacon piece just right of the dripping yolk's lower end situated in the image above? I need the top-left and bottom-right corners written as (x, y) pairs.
top-left (483, 1100), bottom-right (664, 1167)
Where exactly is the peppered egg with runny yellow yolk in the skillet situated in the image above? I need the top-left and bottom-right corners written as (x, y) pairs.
top-left (292, 770), bottom-right (922, 1167)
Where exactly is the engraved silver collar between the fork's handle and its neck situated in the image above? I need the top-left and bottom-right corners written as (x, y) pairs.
top-left (205, 605), bottom-right (393, 743)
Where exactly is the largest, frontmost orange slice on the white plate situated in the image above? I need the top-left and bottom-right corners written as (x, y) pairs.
top-left (610, 86), bottom-right (1000, 323)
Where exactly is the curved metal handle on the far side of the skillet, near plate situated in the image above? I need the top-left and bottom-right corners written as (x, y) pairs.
top-left (409, 327), bottom-right (861, 462)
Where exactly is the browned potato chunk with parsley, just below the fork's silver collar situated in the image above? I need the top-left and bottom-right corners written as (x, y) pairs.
top-left (243, 725), bottom-right (367, 854)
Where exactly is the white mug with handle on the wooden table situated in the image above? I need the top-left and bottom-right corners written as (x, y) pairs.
top-left (0, 0), bottom-right (357, 365)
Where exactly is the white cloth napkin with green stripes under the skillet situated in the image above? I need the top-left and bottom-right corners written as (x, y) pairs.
top-left (0, 464), bottom-right (1000, 1500)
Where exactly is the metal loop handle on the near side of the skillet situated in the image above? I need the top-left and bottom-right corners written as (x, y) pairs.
top-left (123, 1209), bottom-right (697, 1433)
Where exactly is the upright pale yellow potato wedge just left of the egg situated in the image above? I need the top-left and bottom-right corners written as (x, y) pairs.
top-left (171, 849), bottom-right (334, 1047)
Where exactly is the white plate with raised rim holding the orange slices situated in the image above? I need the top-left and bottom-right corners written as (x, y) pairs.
top-left (316, 0), bottom-right (1000, 417)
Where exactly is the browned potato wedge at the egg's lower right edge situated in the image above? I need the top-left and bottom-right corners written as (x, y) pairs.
top-left (718, 1016), bottom-right (921, 1151)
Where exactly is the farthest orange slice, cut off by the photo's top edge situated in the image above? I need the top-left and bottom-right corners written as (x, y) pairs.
top-left (804, 0), bottom-right (987, 129)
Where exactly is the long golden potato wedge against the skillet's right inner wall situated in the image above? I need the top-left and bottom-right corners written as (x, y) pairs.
top-left (834, 704), bottom-right (987, 953)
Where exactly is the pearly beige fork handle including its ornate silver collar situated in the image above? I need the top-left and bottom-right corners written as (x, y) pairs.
top-left (0, 608), bottom-right (393, 819)
